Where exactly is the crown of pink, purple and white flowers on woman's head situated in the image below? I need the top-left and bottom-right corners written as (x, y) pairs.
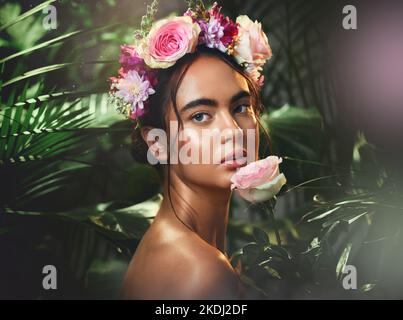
top-left (109, 0), bottom-right (272, 120)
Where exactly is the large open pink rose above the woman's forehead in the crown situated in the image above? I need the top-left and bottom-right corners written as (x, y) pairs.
top-left (139, 16), bottom-right (200, 69)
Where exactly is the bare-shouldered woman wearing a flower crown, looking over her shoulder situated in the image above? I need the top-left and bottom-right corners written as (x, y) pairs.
top-left (112, 4), bottom-right (271, 299)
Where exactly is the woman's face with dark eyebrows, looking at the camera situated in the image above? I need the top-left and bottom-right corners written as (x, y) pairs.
top-left (167, 56), bottom-right (259, 189)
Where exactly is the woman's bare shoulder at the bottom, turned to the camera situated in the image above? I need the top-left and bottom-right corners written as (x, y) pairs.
top-left (123, 226), bottom-right (240, 299)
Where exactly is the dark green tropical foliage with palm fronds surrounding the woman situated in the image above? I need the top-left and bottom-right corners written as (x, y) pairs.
top-left (0, 0), bottom-right (403, 299)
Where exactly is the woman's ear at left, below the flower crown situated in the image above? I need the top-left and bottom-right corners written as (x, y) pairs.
top-left (140, 126), bottom-right (168, 164)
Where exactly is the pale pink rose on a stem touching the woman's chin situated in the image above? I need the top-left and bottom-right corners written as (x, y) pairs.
top-left (231, 156), bottom-right (287, 202)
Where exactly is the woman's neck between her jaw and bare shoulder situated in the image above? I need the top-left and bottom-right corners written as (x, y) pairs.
top-left (160, 171), bottom-right (231, 254)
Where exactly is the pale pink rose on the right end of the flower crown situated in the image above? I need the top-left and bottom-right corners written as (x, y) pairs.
top-left (234, 15), bottom-right (272, 66)
